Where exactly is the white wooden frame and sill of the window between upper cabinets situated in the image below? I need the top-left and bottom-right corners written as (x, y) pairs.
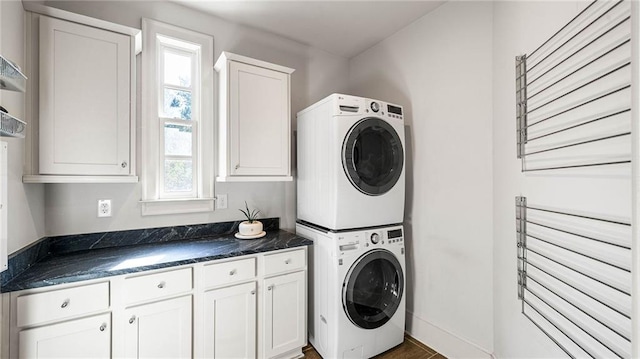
top-left (140, 18), bottom-right (215, 216)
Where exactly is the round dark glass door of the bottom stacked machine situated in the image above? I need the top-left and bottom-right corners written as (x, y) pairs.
top-left (342, 249), bottom-right (404, 329)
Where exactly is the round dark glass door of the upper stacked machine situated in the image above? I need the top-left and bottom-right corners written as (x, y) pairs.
top-left (342, 117), bottom-right (404, 196)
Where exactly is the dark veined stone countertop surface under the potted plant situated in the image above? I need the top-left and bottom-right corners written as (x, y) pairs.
top-left (1, 218), bottom-right (313, 293)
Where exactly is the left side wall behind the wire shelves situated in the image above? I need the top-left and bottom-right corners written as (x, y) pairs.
top-left (0, 0), bottom-right (44, 253)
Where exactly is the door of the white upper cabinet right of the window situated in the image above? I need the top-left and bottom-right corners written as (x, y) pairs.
top-left (229, 61), bottom-right (290, 176)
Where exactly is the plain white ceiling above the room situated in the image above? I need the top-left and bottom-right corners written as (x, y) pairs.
top-left (173, 0), bottom-right (444, 58)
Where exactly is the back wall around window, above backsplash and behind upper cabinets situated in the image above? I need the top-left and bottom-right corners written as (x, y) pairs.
top-left (29, 1), bottom-right (348, 239)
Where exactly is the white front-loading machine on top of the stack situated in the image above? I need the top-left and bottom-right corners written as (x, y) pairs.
top-left (297, 94), bottom-right (405, 230)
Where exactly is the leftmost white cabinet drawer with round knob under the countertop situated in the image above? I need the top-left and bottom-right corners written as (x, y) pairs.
top-left (16, 282), bottom-right (109, 327)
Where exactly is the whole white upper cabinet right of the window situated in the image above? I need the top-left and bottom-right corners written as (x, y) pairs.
top-left (215, 52), bottom-right (294, 182)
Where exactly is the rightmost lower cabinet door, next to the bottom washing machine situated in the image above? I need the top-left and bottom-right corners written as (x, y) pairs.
top-left (264, 271), bottom-right (307, 358)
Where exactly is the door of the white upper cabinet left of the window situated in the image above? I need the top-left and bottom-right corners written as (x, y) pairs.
top-left (39, 16), bottom-right (131, 175)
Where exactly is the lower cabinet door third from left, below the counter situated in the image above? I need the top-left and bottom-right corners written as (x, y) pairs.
top-left (204, 282), bottom-right (256, 358)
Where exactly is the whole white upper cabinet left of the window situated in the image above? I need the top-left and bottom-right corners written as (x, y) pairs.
top-left (23, 8), bottom-right (138, 183)
